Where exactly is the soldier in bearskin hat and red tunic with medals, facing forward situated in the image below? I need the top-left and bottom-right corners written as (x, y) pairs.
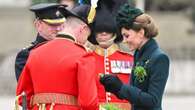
top-left (89, 0), bottom-right (133, 110)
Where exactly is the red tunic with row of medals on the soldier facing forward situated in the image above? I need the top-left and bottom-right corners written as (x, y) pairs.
top-left (93, 44), bottom-right (133, 110)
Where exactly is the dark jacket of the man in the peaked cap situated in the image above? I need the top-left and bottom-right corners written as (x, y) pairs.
top-left (15, 35), bottom-right (47, 81)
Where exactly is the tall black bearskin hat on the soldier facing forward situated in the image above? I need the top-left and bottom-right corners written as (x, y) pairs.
top-left (88, 0), bottom-right (128, 44)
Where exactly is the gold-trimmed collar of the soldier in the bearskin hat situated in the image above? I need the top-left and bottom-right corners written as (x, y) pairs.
top-left (95, 44), bottom-right (119, 56)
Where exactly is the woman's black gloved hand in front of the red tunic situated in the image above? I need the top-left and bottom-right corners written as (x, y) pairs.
top-left (100, 74), bottom-right (123, 94)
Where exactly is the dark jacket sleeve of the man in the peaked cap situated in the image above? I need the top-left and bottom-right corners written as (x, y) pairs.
top-left (15, 49), bottom-right (29, 81)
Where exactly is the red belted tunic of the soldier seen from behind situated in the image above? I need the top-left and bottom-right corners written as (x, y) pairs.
top-left (16, 38), bottom-right (98, 110)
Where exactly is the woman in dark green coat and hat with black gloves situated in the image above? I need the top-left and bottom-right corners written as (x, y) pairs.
top-left (100, 4), bottom-right (169, 110)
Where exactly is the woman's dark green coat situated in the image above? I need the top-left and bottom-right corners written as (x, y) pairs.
top-left (119, 39), bottom-right (169, 110)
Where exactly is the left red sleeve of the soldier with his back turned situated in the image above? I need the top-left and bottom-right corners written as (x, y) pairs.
top-left (16, 54), bottom-right (34, 109)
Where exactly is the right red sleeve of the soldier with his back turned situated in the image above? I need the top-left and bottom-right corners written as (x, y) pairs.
top-left (78, 55), bottom-right (98, 110)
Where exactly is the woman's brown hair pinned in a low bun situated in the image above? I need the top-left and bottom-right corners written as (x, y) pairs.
top-left (132, 13), bottom-right (158, 38)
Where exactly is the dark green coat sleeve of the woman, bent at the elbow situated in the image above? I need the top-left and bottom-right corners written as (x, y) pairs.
top-left (119, 55), bottom-right (169, 107)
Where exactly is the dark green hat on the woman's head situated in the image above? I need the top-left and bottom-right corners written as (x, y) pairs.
top-left (116, 4), bottom-right (143, 29)
